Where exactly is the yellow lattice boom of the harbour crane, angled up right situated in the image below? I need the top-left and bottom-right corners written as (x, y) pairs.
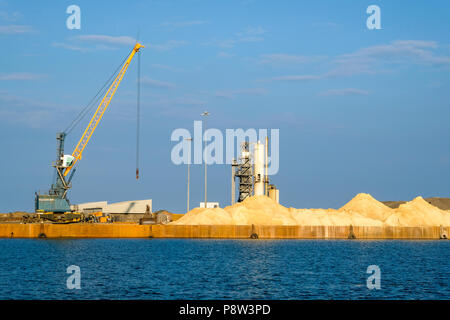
top-left (63, 43), bottom-right (144, 177)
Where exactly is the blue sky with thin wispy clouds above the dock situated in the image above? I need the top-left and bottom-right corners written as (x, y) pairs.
top-left (0, 0), bottom-right (450, 212)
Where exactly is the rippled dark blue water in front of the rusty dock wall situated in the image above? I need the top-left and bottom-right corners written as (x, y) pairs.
top-left (0, 239), bottom-right (450, 299)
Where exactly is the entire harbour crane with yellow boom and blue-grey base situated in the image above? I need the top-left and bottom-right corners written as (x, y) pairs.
top-left (35, 43), bottom-right (144, 223)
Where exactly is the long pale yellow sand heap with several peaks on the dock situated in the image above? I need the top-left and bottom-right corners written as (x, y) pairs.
top-left (171, 193), bottom-right (450, 226)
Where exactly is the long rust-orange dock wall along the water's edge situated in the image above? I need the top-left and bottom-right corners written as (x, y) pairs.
top-left (0, 223), bottom-right (450, 239)
